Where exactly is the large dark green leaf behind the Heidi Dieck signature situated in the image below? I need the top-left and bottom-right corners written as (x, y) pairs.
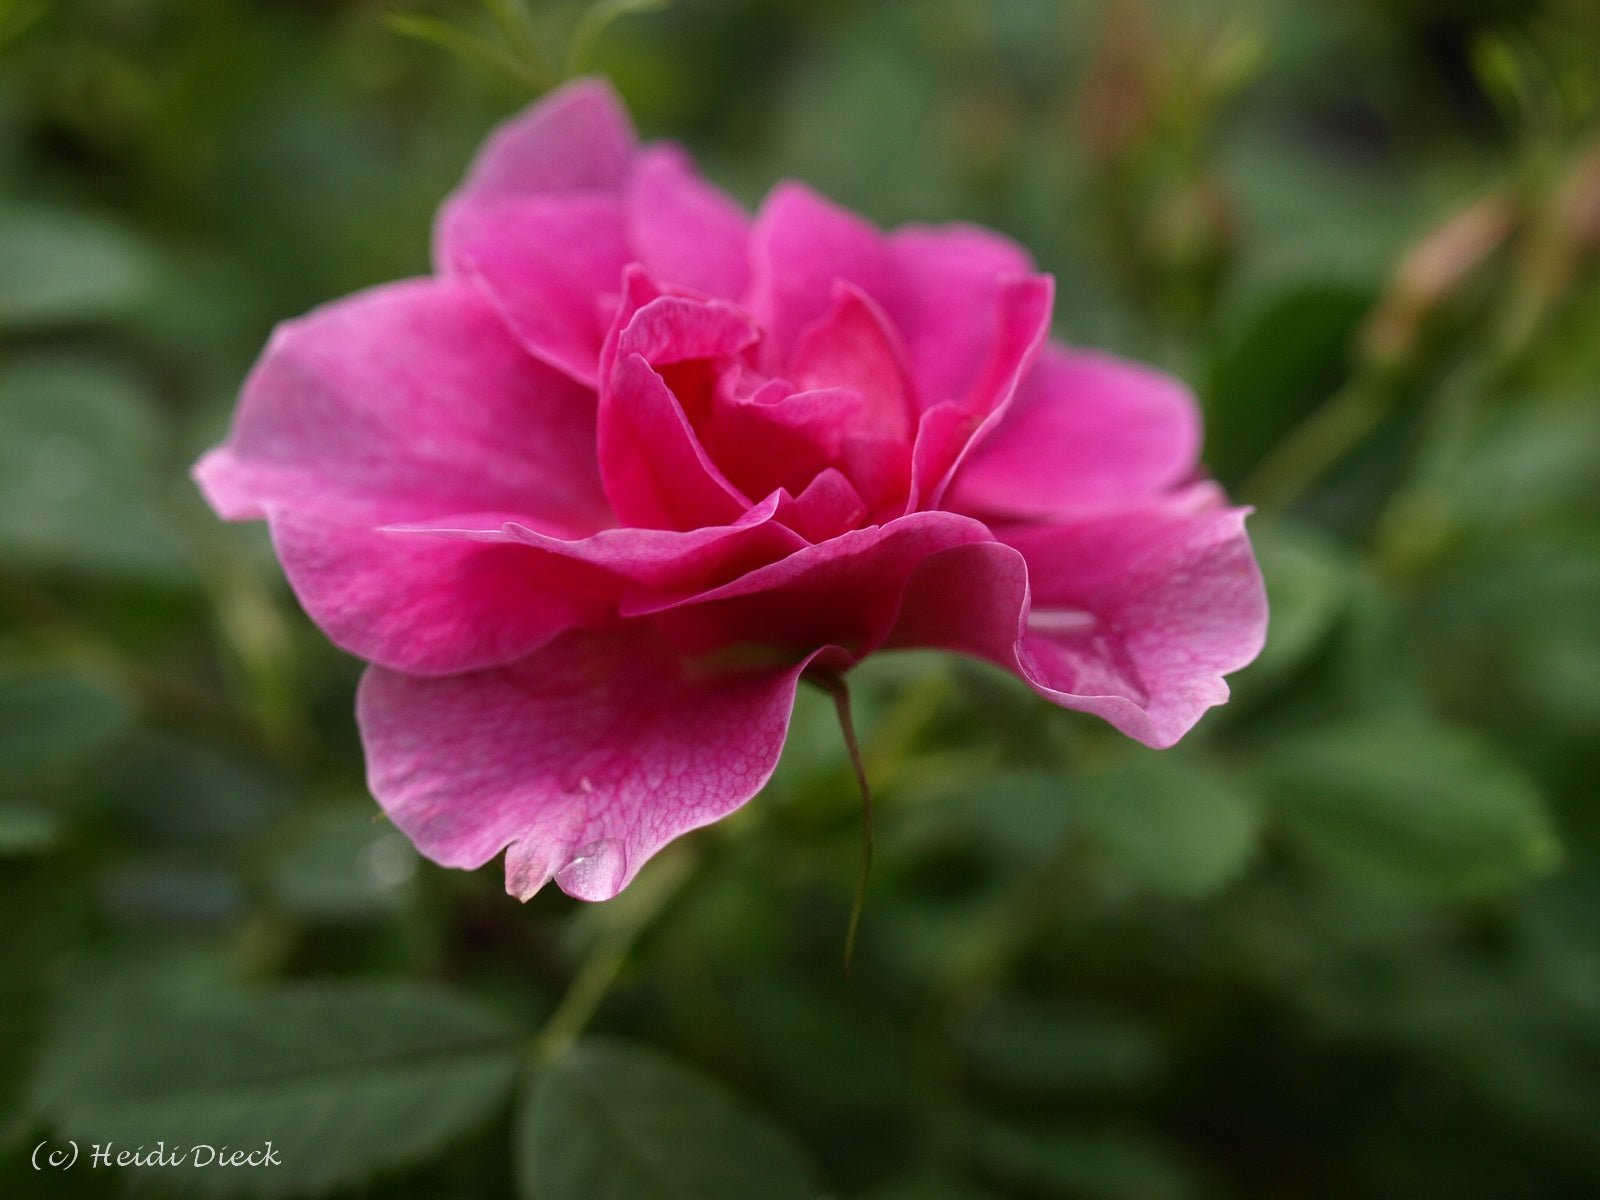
top-left (34, 984), bottom-right (520, 1197)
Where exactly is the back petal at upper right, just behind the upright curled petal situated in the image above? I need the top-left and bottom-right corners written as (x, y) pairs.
top-left (890, 224), bottom-right (1034, 408)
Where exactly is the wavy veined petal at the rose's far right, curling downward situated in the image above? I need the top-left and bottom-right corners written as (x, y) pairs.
top-left (891, 498), bottom-right (1267, 747)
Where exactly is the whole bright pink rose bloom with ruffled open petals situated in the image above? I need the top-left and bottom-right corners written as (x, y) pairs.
top-left (195, 80), bottom-right (1266, 899)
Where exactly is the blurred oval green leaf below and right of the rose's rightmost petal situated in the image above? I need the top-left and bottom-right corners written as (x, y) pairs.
top-left (1261, 715), bottom-right (1560, 899)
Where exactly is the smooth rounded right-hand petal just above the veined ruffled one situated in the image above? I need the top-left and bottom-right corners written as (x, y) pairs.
top-left (946, 346), bottom-right (1200, 518)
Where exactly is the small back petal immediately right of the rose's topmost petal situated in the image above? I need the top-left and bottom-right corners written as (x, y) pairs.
top-left (627, 146), bottom-right (750, 299)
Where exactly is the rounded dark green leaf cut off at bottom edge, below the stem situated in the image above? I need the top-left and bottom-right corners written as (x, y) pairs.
top-left (517, 1040), bottom-right (818, 1200)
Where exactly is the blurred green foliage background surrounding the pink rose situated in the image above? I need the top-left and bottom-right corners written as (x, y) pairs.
top-left (0, 0), bottom-right (1600, 1200)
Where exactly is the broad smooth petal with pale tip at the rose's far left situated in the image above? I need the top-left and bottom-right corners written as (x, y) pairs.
top-left (195, 280), bottom-right (610, 534)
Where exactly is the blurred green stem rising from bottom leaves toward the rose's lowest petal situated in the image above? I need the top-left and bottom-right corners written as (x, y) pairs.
top-left (533, 843), bottom-right (696, 1062)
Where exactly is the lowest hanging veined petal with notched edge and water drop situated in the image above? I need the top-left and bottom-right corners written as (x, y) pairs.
top-left (357, 626), bottom-right (844, 901)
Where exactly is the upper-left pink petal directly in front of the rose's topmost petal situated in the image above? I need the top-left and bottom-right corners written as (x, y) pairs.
top-left (435, 194), bottom-right (629, 387)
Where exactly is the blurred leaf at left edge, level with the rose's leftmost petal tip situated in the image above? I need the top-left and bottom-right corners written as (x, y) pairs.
top-left (0, 357), bottom-right (182, 579)
